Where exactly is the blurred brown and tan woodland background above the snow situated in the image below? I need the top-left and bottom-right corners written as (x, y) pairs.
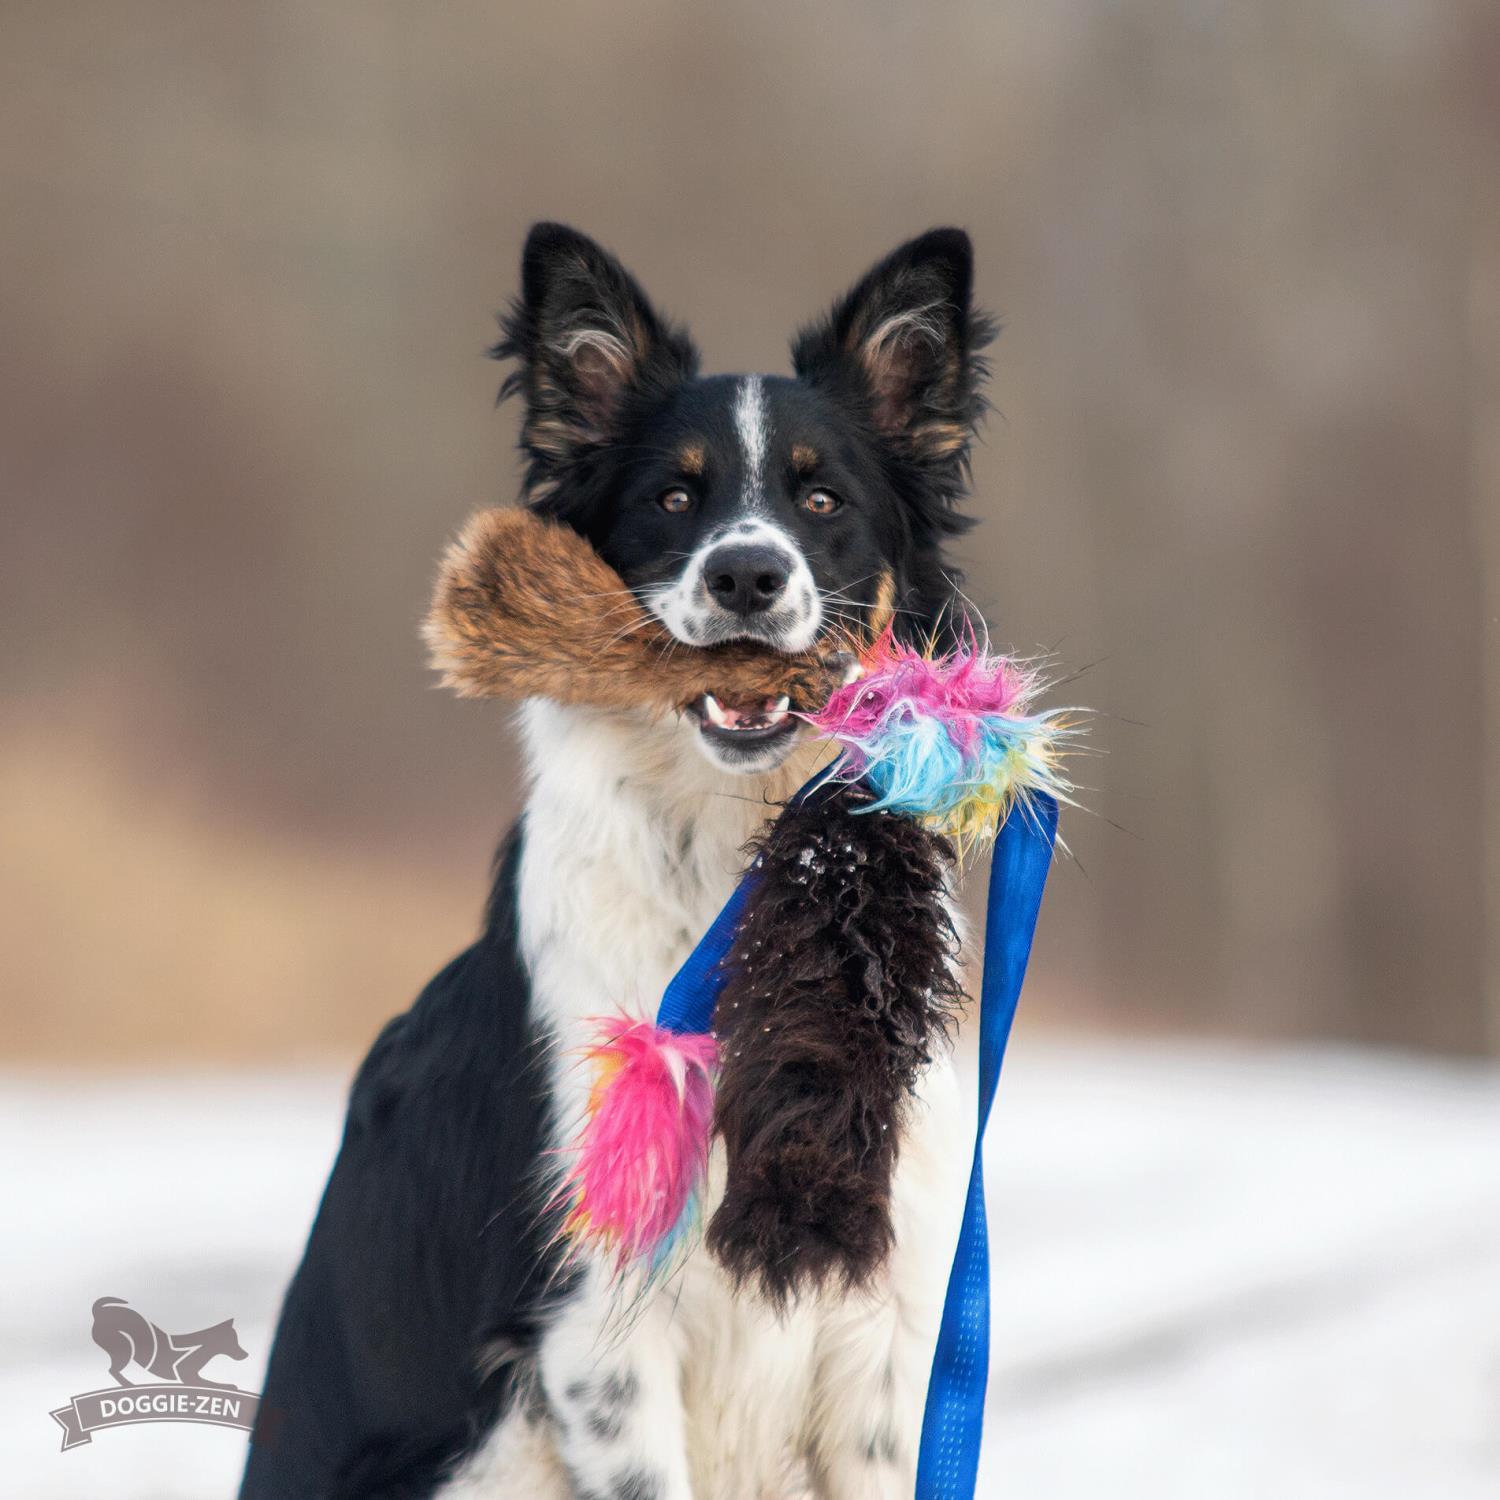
top-left (0, 0), bottom-right (1500, 1064)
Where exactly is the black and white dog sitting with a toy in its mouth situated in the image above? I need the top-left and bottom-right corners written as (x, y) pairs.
top-left (242, 224), bottom-right (993, 1500)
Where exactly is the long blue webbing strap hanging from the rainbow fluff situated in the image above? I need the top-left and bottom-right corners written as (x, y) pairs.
top-left (917, 797), bottom-right (1058, 1500)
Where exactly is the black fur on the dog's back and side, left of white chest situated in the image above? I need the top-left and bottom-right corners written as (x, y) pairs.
top-left (240, 839), bottom-right (567, 1500)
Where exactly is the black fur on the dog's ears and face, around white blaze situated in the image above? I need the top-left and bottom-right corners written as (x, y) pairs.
top-left (492, 224), bottom-right (995, 635)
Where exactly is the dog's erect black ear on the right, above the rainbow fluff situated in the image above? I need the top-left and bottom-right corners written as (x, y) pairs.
top-left (792, 230), bottom-right (995, 489)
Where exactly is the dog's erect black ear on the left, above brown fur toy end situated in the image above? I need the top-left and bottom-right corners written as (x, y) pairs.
top-left (491, 224), bottom-right (698, 501)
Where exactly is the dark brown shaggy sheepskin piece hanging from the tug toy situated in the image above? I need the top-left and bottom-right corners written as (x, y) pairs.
top-left (708, 788), bottom-right (963, 1304)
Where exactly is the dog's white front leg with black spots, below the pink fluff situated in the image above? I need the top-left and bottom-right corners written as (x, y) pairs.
top-left (540, 1265), bottom-right (693, 1500)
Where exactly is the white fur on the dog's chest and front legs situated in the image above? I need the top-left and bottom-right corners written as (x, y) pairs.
top-left (450, 702), bottom-right (969, 1500)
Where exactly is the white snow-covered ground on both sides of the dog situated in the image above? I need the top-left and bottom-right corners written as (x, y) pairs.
top-left (0, 1035), bottom-right (1500, 1500)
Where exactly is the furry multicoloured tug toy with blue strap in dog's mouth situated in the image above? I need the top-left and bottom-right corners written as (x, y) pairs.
top-left (426, 512), bottom-right (1074, 1500)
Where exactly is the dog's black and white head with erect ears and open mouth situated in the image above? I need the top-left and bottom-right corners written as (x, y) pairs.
top-left (494, 224), bottom-right (992, 771)
